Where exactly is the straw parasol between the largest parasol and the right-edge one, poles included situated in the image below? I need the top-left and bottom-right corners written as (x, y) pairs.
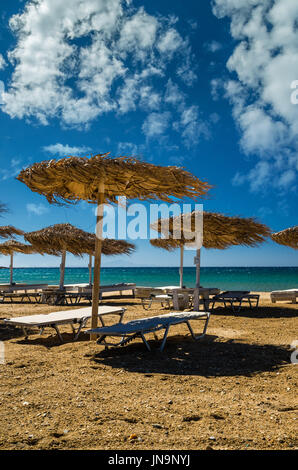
top-left (150, 211), bottom-right (270, 309)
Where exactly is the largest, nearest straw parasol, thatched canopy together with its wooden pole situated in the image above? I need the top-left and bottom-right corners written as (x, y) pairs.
top-left (18, 154), bottom-right (210, 339)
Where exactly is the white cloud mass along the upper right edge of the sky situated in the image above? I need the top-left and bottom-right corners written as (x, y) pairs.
top-left (212, 0), bottom-right (298, 191)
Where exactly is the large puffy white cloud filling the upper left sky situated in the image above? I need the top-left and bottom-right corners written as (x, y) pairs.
top-left (2, 0), bottom-right (196, 128)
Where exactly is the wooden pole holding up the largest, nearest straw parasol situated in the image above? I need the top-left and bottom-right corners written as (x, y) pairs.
top-left (90, 181), bottom-right (105, 341)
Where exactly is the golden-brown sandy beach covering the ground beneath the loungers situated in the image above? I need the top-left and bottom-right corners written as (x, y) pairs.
top-left (0, 293), bottom-right (298, 450)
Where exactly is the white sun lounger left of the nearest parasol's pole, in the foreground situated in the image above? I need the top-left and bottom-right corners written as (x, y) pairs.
top-left (3, 306), bottom-right (125, 342)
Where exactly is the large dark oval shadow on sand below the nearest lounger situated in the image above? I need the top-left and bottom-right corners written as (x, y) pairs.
top-left (91, 335), bottom-right (290, 377)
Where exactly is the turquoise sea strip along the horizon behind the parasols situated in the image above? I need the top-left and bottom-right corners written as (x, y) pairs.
top-left (0, 267), bottom-right (298, 291)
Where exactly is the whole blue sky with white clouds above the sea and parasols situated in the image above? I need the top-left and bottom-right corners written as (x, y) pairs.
top-left (0, 0), bottom-right (298, 266)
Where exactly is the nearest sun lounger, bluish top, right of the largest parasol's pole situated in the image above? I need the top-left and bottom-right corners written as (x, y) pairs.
top-left (86, 312), bottom-right (210, 351)
